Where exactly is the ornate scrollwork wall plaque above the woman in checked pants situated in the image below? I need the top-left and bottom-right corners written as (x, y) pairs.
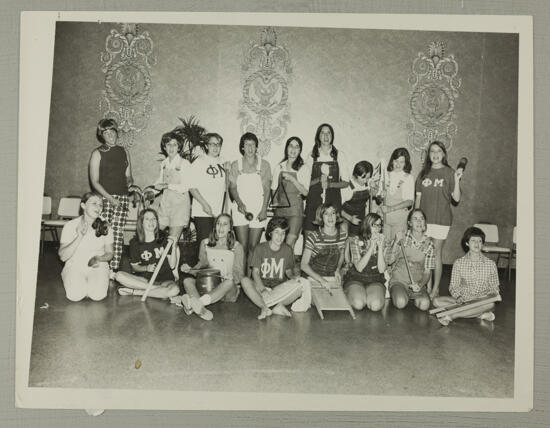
top-left (99, 23), bottom-right (157, 147)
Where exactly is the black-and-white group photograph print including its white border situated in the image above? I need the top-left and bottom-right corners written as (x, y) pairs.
top-left (18, 10), bottom-right (533, 410)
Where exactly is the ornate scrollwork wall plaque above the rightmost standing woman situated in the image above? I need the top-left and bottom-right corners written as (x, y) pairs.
top-left (407, 42), bottom-right (462, 160)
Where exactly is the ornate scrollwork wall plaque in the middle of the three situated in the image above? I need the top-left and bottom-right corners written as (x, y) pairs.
top-left (238, 27), bottom-right (292, 156)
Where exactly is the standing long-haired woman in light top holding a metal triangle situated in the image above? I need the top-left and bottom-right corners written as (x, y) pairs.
top-left (271, 137), bottom-right (311, 249)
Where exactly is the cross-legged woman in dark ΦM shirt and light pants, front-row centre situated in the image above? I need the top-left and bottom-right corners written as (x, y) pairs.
top-left (242, 217), bottom-right (311, 319)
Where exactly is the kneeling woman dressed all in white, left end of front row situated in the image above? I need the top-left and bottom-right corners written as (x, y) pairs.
top-left (59, 192), bottom-right (113, 302)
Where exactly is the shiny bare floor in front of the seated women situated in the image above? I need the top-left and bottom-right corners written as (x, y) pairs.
top-left (29, 244), bottom-right (515, 397)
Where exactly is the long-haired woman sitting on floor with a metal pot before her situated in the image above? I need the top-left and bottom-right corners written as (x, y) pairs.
top-left (181, 214), bottom-right (244, 321)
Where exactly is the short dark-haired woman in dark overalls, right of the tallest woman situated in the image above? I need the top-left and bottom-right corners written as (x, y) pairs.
top-left (342, 161), bottom-right (373, 236)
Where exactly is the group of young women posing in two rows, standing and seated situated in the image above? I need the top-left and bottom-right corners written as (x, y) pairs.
top-left (59, 119), bottom-right (498, 323)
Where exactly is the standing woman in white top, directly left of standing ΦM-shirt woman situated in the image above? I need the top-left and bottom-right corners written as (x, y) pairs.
top-left (380, 147), bottom-right (414, 242)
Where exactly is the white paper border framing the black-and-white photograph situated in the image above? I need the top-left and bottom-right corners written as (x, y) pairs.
top-left (15, 11), bottom-right (534, 412)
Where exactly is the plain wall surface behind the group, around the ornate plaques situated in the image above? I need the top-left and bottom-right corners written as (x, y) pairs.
top-left (44, 22), bottom-right (518, 263)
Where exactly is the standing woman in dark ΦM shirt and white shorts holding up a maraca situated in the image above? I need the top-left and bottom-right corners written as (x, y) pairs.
top-left (416, 141), bottom-right (463, 299)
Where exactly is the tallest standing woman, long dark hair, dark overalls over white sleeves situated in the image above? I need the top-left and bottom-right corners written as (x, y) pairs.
top-left (304, 123), bottom-right (349, 231)
